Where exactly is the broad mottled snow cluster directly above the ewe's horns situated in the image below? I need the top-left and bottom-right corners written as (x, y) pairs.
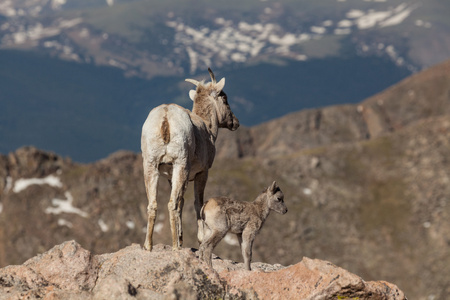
top-left (166, 18), bottom-right (314, 73)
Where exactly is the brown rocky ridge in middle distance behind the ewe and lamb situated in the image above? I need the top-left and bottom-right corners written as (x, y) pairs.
top-left (0, 58), bottom-right (450, 299)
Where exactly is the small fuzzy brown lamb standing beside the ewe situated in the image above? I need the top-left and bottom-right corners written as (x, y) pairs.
top-left (199, 181), bottom-right (287, 270)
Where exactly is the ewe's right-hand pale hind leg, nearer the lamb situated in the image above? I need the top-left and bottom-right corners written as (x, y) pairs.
top-left (168, 164), bottom-right (189, 250)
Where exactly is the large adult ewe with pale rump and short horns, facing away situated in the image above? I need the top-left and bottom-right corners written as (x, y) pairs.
top-left (141, 68), bottom-right (239, 250)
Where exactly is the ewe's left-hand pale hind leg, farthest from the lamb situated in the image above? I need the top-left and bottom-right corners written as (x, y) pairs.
top-left (144, 159), bottom-right (159, 251)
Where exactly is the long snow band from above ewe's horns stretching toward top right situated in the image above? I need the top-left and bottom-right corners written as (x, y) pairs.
top-left (166, 3), bottom-right (415, 73)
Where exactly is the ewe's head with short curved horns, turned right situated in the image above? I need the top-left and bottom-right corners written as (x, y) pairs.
top-left (186, 68), bottom-right (239, 130)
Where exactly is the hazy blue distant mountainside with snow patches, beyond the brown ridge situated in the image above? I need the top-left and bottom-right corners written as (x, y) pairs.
top-left (0, 0), bottom-right (450, 162)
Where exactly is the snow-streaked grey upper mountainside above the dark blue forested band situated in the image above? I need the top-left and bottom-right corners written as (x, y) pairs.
top-left (0, 0), bottom-right (450, 77)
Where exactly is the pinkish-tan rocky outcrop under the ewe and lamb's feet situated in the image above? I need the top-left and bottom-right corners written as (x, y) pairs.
top-left (0, 241), bottom-right (406, 300)
